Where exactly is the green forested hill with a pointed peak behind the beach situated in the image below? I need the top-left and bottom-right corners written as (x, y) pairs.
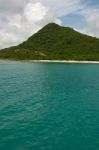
top-left (0, 23), bottom-right (99, 61)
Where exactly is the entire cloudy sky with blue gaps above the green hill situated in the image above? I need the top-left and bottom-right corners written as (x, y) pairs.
top-left (0, 0), bottom-right (99, 49)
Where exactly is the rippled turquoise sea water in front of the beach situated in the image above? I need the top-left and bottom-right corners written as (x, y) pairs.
top-left (0, 62), bottom-right (99, 150)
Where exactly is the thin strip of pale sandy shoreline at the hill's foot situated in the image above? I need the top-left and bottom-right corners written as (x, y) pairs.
top-left (0, 59), bottom-right (99, 64)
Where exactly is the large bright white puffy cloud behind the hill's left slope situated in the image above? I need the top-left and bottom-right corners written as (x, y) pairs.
top-left (0, 2), bottom-right (59, 48)
